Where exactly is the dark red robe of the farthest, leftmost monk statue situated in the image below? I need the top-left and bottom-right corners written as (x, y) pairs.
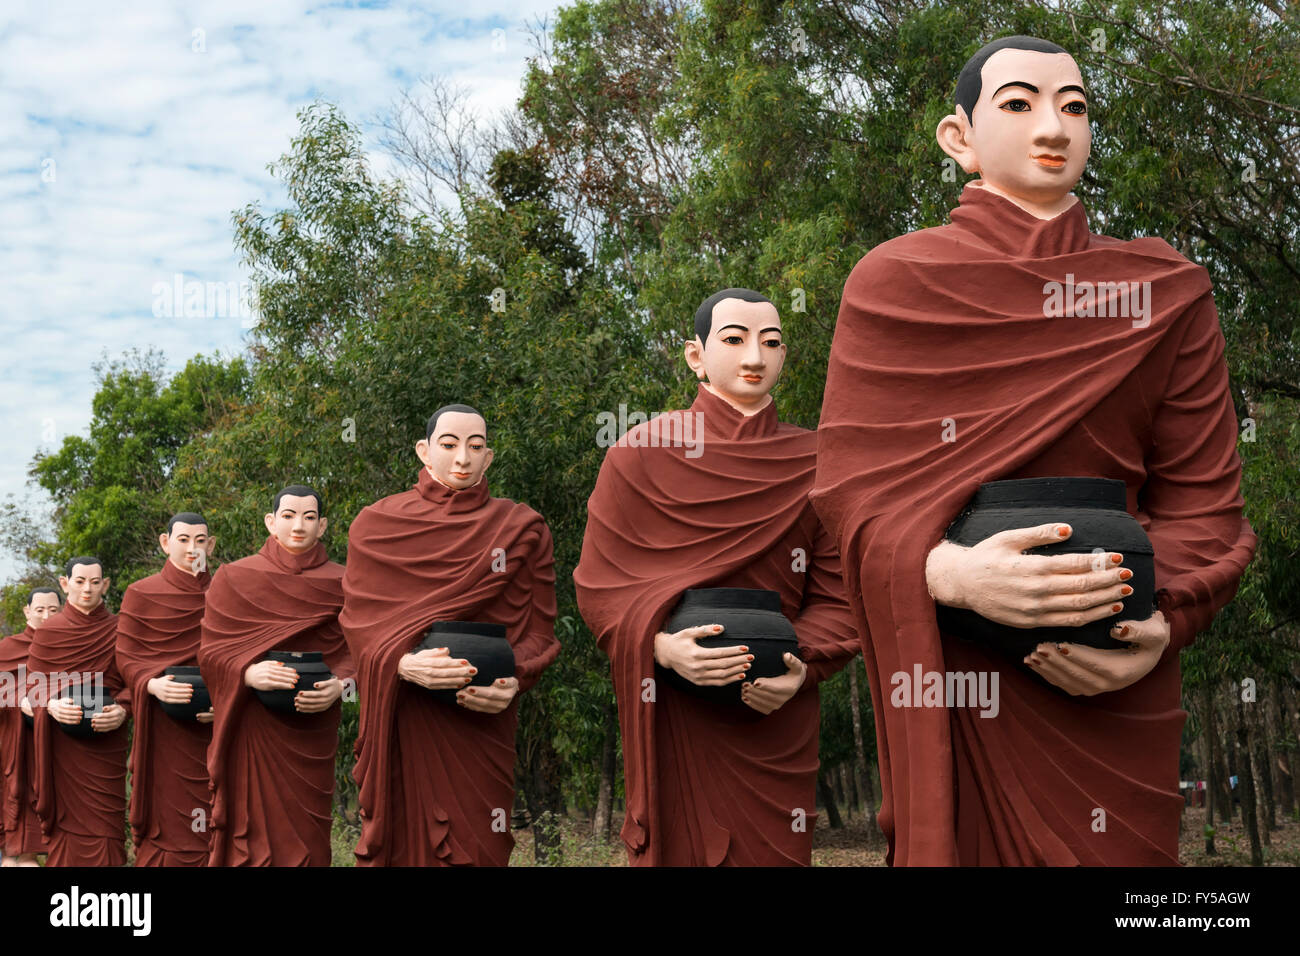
top-left (0, 624), bottom-right (46, 856)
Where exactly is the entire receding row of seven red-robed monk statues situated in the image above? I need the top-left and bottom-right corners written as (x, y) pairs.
top-left (0, 36), bottom-right (1255, 866)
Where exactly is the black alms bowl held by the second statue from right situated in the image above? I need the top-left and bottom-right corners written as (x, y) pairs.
top-left (655, 588), bottom-right (801, 704)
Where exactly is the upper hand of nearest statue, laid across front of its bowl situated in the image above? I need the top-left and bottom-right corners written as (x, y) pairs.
top-left (926, 524), bottom-right (1134, 628)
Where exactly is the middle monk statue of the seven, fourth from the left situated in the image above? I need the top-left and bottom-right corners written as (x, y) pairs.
top-left (199, 485), bottom-right (355, 866)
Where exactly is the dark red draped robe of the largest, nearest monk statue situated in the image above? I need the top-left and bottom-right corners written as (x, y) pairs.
top-left (813, 186), bottom-right (1255, 865)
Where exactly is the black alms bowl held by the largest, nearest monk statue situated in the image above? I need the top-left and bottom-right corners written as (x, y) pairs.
top-left (936, 477), bottom-right (1156, 658)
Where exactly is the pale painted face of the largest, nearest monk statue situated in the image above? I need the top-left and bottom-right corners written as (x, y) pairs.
top-left (962, 49), bottom-right (1092, 206)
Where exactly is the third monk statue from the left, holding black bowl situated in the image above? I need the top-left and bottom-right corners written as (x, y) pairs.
top-left (117, 511), bottom-right (216, 866)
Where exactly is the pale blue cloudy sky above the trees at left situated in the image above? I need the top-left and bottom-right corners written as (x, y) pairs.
top-left (0, 0), bottom-right (560, 580)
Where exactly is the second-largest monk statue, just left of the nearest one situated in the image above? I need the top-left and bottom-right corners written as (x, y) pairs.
top-left (573, 289), bottom-right (857, 866)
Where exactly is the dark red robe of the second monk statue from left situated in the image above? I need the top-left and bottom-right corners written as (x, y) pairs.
top-left (27, 602), bottom-right (131, 866)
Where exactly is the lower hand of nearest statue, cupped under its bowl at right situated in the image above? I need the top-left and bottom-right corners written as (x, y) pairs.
top-left (1024, 611), bottom-right (1169, 697)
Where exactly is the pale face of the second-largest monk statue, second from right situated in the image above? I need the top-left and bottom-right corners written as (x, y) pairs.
top-left (686, 299), bottom-right (785, 406)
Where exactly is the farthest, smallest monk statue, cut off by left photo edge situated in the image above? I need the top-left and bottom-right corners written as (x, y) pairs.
top-left (0, 588), bottom-right (59, 866)
